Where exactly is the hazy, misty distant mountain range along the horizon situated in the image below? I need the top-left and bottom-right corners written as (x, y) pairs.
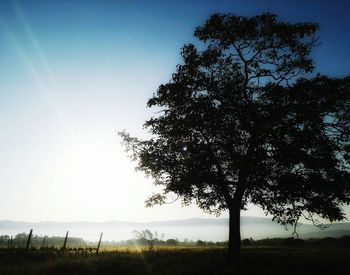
top-left (0, 217), bottom-right (350, 241)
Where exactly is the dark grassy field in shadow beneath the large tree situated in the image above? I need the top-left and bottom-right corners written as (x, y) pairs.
top-left (0, 247), bottom-right (350, 275)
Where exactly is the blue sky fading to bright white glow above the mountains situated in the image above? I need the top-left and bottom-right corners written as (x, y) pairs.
top-left (0, 0), bottom-right (350, 221)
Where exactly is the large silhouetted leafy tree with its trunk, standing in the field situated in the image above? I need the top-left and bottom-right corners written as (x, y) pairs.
top-left (120, 13), bottom-right (350, 256)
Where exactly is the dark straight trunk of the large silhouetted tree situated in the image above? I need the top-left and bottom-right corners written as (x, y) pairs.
top-left (228, 203), bottom-right (241, 263)
